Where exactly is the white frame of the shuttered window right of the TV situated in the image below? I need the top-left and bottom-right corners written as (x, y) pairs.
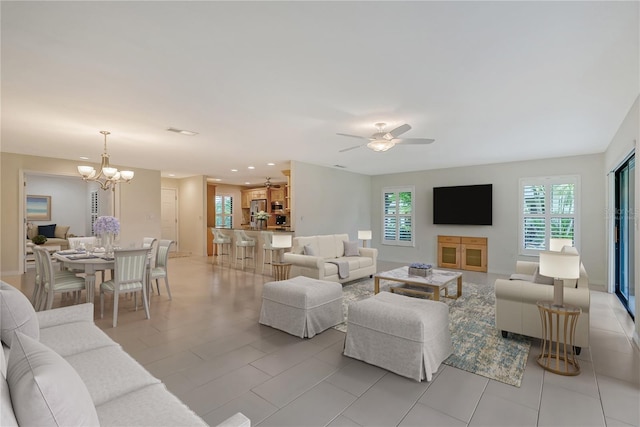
top-left (518, 175), bottom-right (581, 256)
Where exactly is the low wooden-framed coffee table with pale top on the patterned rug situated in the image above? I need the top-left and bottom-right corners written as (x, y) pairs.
top-left (374, 266), bottom-right (462, 301)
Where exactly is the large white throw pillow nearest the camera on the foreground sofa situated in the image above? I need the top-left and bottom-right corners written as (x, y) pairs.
top-left (7, 332), bottom-right (100, 426)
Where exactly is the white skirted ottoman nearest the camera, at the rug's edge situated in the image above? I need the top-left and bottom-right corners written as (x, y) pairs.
top-left (344, 292), bottom-right (453, 381)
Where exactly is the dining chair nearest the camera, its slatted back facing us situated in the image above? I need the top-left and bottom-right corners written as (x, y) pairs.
top-left (100, 248), bottom-right (151, 328)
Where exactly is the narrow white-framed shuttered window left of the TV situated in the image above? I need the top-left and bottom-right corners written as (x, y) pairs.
top-left (382, 187), bottom-right (414, 246)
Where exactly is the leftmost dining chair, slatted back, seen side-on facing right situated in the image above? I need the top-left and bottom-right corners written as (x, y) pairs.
top-left (33, 246), bottom-right (86, 311)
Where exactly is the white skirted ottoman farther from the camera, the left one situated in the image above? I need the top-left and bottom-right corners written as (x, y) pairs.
top-left (260, 276), bottom-right (343, 338)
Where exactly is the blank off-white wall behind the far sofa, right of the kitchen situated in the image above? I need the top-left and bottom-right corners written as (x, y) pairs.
top-left (291, 161), bottom-right (371, 240)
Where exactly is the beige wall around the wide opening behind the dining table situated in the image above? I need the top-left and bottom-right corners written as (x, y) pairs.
top-left (0, 153), bottom-right (160, 275)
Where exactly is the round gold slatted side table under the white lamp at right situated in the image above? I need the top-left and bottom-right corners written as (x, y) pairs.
top-left (537, 301), bottom-right (582, 375)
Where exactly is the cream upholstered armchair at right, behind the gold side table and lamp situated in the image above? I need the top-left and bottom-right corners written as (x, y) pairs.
top-left (495, 261), bottom-right (590, 354)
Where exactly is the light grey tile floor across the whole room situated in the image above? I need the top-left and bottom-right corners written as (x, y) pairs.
top-left (4, 256), bottom-right (640, 426)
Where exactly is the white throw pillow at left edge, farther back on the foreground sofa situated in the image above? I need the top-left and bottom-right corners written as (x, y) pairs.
top-left (0, 281), bottom-right (40, 347)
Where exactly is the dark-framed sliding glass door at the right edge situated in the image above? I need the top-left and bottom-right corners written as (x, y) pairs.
top-left (614, 154), bottom-right (636, 319)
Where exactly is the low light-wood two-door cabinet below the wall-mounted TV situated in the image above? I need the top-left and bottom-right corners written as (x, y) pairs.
top-left (438, 236), bottom-right (488, 272)
